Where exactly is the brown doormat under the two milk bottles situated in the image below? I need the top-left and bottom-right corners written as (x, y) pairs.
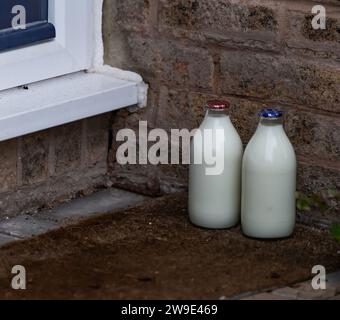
top-left (0, 194), bottom-right (340, 299)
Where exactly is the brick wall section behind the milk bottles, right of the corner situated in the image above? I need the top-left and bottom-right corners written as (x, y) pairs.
top-left (104, 0), bottom-right (340, 205)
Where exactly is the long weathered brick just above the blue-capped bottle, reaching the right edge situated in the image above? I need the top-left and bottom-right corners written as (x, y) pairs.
top-left (221, 52), bottom-right (340, 112)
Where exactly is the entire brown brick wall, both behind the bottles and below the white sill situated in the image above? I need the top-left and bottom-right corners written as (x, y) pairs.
top-left (0, 0), bottom-right (334, 217)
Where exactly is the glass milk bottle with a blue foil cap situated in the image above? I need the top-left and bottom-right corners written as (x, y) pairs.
top-left (241, 109), bottom-right (296, 238)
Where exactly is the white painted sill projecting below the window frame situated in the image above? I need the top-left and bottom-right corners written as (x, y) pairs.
top-left (0, 72), bottom-right (147, 141)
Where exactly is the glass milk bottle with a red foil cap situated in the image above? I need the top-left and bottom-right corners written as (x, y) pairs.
top-left (189, 101), bottom-right (243, 229)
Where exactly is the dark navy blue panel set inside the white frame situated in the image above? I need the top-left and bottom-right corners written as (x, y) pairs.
top-left (0, 0), bottom-right (55, 51)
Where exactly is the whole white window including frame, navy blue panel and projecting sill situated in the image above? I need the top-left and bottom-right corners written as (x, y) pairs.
top-left (0, 0), bottom-right (148, 141)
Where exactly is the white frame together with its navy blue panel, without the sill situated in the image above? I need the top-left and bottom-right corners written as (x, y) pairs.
top-left (0, 0), bottom-right (93, 90)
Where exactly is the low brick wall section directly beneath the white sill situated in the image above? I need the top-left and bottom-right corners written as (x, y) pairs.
top-left (0, 114), bottom-right (111, 219)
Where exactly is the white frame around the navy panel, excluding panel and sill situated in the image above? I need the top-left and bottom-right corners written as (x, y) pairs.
top-left (0, 0), bottom-right (94, 90)
